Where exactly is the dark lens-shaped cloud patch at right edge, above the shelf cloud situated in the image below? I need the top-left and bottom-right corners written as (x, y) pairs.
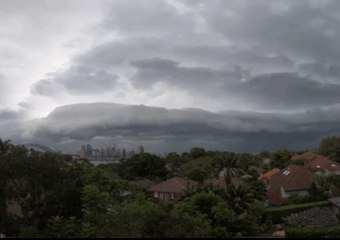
top-left (231, 73), bottom-right (340, 109)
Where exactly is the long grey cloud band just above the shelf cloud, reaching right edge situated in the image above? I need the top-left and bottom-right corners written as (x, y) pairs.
top-left (132, 59), bottom-right (340, 109)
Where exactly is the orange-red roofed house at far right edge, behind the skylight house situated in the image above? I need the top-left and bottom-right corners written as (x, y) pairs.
top-left (305, 157), bottom-right (340, 175)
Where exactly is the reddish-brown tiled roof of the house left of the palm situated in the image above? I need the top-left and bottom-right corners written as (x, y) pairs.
top-left (148, 177), bottom-right (198, 193)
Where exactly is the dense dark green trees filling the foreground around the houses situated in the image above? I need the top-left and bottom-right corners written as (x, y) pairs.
top-left (0, 135), bottom-right (340, 238)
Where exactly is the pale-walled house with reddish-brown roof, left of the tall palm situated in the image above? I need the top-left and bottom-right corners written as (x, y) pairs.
top-left (148, 177), bottom-right (198, 201)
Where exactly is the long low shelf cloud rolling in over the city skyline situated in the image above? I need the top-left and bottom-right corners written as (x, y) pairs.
top-left (16, 103), bottom-right (340, 151)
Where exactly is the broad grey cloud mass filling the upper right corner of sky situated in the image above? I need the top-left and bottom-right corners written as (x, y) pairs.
top-left (206, 1), bottom-right (340, 62)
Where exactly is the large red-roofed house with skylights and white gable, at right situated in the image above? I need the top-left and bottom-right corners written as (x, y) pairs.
top-left (267, 165), bottom-right (315, 205)
